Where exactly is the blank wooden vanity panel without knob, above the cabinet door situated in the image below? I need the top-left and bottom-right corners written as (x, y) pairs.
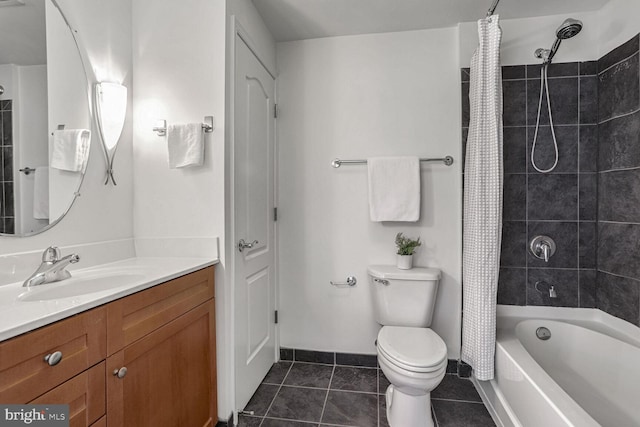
top-left (107, 267), bottom-right (214, 355)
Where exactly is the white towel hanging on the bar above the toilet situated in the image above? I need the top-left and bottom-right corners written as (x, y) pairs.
top-left (367, 157), bottom-right (420, 222)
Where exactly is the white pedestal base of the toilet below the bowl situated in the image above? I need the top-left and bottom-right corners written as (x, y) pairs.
top-left (385, 384), bottom-right (434, 427)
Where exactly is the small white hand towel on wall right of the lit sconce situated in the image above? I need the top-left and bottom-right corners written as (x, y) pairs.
top-left (167, 123), bottom-right (204, 169)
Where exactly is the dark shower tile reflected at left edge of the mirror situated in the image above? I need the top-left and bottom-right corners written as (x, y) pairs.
top-left (0, 100), bottom-right (15, 234)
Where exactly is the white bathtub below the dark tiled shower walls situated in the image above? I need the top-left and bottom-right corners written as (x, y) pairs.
top-left (476, 306), bottom-right (640, 427)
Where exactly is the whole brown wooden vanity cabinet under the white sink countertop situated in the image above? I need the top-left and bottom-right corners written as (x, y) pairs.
top-left (0, 265), bottom-right (217, 427)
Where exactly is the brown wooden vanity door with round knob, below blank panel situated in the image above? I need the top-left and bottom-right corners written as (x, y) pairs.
top-left (107, 299), bottom-right (217, 427)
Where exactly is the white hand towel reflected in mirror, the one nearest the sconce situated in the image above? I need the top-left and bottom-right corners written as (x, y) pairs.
top-left (51, 129), bottom-right (91, 172)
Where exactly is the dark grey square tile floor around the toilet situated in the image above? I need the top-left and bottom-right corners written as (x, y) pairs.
top-left (238, 361), bottom-right (495, 427)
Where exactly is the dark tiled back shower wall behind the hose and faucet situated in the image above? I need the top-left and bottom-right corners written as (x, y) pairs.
top-left (462, 62), bottom-right (598, 307)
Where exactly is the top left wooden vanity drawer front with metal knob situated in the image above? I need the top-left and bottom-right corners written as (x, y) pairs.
top-left (0, 307), bottom-right (107, 403)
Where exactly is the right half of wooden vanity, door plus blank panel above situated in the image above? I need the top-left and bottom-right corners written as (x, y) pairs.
top-left (107, 268), bottom-right (217, 427)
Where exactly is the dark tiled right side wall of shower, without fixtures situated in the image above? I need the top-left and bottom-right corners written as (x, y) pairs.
top-left (595, 36), bottom-right (640, 326)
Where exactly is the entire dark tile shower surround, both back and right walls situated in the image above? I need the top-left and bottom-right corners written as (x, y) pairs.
top-left (462, 36), bottom-right (640, 326)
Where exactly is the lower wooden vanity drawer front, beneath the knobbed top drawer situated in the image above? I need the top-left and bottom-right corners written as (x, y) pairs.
top-left (29, 362), bottom-right (106, 427)
